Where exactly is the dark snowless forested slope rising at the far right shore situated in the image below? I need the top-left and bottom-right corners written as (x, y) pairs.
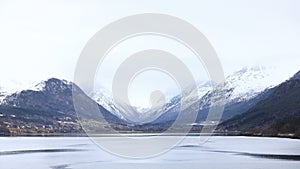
top-left (220, 74), bottom-right (300, 137)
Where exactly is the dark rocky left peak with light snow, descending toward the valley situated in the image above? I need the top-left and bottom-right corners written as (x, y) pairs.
top-left (2, 78), bottom-right (123, 123)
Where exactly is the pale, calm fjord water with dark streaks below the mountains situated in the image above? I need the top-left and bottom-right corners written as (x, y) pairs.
top-left (0, 136), bottom-right (300, 169)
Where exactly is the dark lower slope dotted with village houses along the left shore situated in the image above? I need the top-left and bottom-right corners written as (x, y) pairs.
top-left (0, 105), bottom-right (83, 135)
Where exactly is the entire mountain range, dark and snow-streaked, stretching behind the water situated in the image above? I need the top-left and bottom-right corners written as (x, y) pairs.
top-left (0, 67), bottom-right (300, 136)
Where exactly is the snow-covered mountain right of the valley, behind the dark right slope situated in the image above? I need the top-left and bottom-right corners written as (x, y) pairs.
top-left (155, 66), bottom-right (280, 123)
